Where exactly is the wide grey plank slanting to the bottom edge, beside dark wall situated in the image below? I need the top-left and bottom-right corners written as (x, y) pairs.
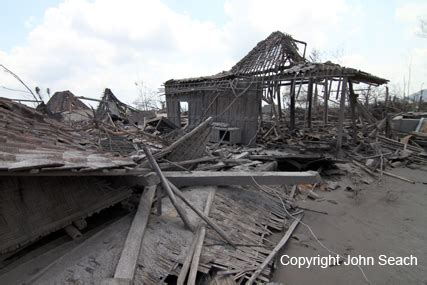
top-left (114, 185), bottom-right (157, 281)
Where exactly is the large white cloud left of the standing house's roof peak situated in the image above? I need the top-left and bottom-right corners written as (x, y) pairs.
top-left (0, 0), bottom-right (229, 102)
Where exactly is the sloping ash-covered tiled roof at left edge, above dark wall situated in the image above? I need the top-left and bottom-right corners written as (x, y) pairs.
top-left (0, 98), bottom-right (135, 175)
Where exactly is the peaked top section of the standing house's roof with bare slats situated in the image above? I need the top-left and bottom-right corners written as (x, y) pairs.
top-left (231, 31), bottom-right (305, 75)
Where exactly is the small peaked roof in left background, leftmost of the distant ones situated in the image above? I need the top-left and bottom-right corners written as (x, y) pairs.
top-left (46, 90), bottom-right (90, 114)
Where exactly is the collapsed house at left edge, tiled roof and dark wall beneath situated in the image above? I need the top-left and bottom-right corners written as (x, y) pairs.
top-left (0, 98), bottom-right (135, 255)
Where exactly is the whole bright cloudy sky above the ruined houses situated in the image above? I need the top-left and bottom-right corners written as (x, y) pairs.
top-left (0, 0), bottom-right (427, 103)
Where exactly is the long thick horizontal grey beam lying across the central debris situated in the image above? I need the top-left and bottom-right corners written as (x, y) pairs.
top-left (164, 171), bottom-right (321, 187)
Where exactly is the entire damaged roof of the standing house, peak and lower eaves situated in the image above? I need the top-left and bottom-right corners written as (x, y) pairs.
top-left (165, 31), bottom-right (388, 90)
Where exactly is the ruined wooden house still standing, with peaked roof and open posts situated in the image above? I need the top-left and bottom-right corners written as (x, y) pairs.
top-left (165, 31), bottom-right (388, 148)
